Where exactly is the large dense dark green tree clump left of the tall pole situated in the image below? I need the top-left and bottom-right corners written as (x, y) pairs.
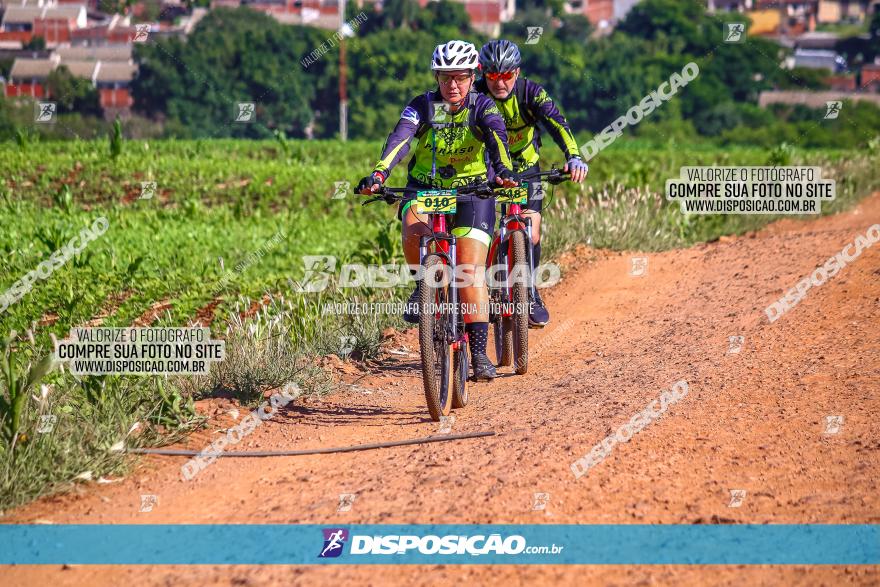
top-left (133, 8), bottom-right (335, 138)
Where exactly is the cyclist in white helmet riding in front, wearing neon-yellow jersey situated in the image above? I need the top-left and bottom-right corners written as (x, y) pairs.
top-left (358, 41), bottom-right (516, 379)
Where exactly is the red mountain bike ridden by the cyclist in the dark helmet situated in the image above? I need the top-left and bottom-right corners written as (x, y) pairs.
top-left (489, 168), bottom-right (571, 375)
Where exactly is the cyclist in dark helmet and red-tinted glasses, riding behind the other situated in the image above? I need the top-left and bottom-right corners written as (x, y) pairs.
top-left (476, 39), bottom-right (588, 327)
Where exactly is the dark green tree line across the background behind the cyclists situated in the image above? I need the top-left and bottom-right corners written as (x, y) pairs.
top-left (0, 0), bottom-right (880, 149)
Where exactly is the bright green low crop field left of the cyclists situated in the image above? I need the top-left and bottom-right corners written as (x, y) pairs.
top-left (0, 141), bottom-right (385, 336)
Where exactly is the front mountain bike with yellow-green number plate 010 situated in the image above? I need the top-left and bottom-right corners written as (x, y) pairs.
top-left (363, 184), bottom-right (493, 421)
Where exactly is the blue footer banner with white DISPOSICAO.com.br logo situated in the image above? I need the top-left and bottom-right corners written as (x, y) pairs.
top-left (0, 524), bottom-right (880, 565)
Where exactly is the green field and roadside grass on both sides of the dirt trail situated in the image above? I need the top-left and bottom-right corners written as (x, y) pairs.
top-left (0, 134), bottom-right (880, 508)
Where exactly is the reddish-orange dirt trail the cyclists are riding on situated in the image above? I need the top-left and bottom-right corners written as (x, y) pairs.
top-left (2, 194), bottom-right (880, 586)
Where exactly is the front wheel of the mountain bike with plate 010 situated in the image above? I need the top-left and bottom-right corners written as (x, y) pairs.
top-left (419, 253), bottom-right (456, 421)
